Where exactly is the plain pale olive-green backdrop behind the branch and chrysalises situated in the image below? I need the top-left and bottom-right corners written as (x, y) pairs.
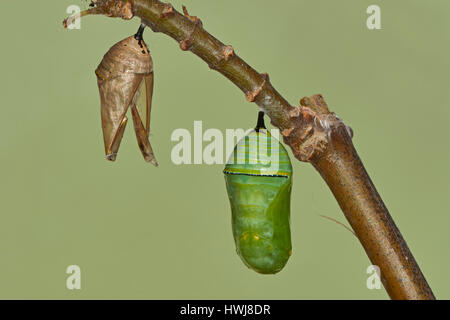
top-left (0, 0), bottom-right (450, 299)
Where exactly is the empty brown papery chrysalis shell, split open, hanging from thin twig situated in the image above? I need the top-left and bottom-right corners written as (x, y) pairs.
top-left (95, 25), bottom-right (158, 166)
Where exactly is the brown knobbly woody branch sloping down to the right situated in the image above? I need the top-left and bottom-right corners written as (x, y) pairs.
top-left (66, 0), bottom-right (434, 299)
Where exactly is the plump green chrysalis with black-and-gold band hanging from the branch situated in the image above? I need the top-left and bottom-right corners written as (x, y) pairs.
top-left (223, 112), bottom-right (292, 274)
